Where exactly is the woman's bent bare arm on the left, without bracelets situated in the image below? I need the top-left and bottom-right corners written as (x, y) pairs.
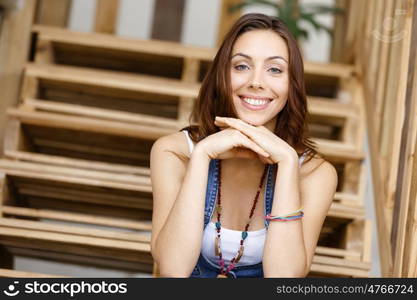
top-left (151, 133), bottom-right (209, 277)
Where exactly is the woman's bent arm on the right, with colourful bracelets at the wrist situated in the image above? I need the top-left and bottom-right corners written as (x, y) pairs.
top-left (263, 157), bottom-right (337, 277)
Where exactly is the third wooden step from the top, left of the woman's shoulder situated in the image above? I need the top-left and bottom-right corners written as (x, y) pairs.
top-left (4, 109), bottom-right (162, 169)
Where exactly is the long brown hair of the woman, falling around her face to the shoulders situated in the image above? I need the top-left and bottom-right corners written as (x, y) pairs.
top-left (185, 13), bottom-right (317, 161)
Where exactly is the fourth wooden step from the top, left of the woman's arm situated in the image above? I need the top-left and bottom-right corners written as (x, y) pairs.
top-left (0, 159), bottom-right (152, 220)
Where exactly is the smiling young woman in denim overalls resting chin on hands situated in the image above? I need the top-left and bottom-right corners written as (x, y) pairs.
top-left (151, 14), bottom-right (337, 277)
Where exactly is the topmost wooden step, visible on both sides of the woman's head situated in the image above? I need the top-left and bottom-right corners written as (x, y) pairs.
top-left (33, 25), bottom-right (354, 91)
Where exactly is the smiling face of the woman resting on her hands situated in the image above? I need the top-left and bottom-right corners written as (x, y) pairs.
top-left (230, 30), bottom-right (289, 131)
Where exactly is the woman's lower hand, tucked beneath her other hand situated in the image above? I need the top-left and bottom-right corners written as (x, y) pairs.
top-left (196, 128), bottom-right (269, 161)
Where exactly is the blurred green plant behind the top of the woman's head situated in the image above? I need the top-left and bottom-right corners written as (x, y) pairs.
top-left (229, 0), bottom-right (344, 40)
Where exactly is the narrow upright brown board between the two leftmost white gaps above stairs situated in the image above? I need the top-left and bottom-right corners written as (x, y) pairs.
top-left (94, 0), bottom-right (119, 34)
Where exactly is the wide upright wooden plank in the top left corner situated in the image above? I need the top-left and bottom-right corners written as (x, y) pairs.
top-left (0, 0), bottom-right (36, 154)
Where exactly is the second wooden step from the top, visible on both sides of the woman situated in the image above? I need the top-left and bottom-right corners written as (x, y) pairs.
top-left (22, 64), bottom-right (363, 158)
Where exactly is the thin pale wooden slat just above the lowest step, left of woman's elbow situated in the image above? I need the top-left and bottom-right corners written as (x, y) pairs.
top-left (3, 206), bottom-right (152, 231)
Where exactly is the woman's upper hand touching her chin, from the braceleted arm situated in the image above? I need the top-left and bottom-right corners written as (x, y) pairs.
top-left (214, 117), bottom-right (298, 163)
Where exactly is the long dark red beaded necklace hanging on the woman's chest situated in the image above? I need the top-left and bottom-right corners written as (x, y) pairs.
top-left (214, 160), bottom-right (268, 278)
